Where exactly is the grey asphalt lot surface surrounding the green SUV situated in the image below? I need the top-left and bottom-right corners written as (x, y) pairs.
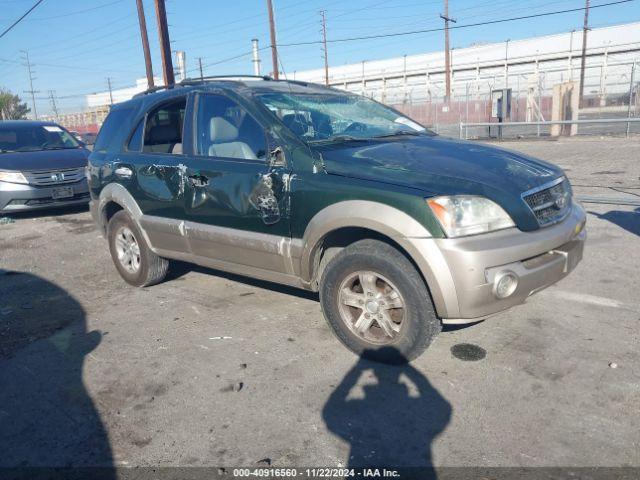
top-left (0, 139), bottom-right (640, 476)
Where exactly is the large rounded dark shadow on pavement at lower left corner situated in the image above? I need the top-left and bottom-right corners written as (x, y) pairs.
top-left (0, 272), bottom-right (116, 479)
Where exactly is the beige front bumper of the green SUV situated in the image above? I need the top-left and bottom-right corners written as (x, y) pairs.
top-left (413, 204), bottom-right (586, 324)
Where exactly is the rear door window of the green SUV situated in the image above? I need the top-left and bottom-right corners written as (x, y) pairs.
top-left (142, 98), bottom-right (187, 155)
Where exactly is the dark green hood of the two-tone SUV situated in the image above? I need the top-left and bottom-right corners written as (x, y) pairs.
top-left (315, 136), bottom-right (563, 230)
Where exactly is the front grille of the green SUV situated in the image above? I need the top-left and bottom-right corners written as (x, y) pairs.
top-left (522, 177), bottom-right (571, 227)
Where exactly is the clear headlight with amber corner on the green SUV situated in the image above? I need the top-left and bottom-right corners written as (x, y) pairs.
top-left (427, 195), bottom-right (515, 238)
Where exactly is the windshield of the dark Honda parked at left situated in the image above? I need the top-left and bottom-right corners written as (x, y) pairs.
top-left (0, 124), bottom-right (80, 153)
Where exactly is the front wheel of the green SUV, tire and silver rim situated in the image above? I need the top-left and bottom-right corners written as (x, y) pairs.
top-left (320, 239), bottom-right (442, 364)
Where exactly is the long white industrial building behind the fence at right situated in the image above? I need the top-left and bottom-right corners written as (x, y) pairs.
top-left (289, 23), bottom-right (640, 104)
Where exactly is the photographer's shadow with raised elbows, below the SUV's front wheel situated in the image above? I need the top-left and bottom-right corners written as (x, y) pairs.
top-left (322, 347), bottom-right (452, 479)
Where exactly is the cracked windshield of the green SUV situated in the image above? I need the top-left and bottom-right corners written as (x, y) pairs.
top-left (259, 93), bottom-right (432, 142)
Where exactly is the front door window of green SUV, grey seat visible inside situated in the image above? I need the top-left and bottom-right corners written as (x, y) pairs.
top-left (197, 95), bottom-right (267, 160)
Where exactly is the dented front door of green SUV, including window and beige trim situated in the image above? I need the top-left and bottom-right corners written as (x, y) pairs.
top-left (180, 94), bottom-right (290, 271)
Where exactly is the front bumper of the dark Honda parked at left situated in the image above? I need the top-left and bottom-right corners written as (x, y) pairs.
top-left (0, 180), bottom-right (89, 213)
